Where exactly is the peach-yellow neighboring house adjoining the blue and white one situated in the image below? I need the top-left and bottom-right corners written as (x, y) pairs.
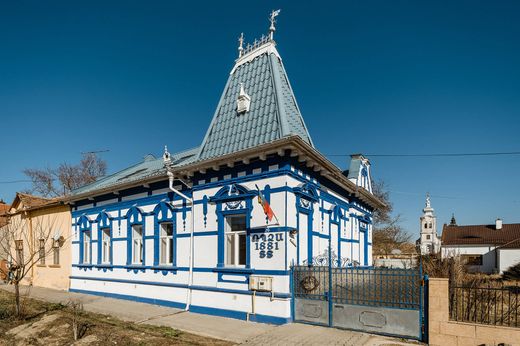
top-left (4, 193), bottom-right (71, 290)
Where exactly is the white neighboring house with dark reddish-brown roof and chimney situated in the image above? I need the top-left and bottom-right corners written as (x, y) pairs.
top-left (442, 218), bottom-right (520, 273)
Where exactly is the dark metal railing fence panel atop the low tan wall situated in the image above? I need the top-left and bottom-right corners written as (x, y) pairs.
top-left (450, 284), bottom-right (520, 327)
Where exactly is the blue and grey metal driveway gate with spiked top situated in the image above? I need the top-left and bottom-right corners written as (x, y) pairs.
top-left (292, 266), bottom-right (425, 341)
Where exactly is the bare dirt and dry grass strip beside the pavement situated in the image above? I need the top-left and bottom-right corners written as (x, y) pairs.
top-left (0, 290), bottom-right (232, 346)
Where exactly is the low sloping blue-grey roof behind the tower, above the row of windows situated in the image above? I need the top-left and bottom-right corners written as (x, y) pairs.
top-left (71, 147), bottom-right (199, 195)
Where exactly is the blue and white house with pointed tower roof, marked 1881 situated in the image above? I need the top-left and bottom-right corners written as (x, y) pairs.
top-left (68, 12), bottom-right (382, 323)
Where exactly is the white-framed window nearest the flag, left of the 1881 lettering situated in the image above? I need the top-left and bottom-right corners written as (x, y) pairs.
top-left (225, 215), bottom-right (246, 266)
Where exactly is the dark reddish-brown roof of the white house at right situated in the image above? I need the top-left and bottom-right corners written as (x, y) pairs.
top-left (441, 223), bottom-right (520, 248)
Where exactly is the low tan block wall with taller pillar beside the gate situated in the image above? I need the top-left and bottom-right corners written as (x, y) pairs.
top-left (428, 278), bottom-right (520, 346)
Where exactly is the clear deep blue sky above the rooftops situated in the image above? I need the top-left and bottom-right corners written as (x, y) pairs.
top-left (0, 0), bottom-right (520, 236)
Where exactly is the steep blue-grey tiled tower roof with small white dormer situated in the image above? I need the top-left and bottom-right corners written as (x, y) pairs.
top-left (198, 42), bottom-right (313, 160)
